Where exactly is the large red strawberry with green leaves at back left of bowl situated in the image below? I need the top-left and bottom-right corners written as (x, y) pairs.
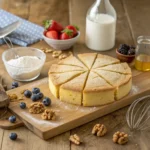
top-left (44, 20), bottom-right (64, 32)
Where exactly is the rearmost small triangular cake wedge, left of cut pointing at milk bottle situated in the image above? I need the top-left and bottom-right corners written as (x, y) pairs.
top-left (78, 53), bottom-right (97, 69)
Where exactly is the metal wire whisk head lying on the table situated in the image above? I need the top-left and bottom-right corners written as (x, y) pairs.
top-left (126, 95), bottom-right (150, 130)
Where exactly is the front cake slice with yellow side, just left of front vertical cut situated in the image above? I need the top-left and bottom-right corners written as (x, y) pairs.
top-left (59, 71), bottom-right (88, 105)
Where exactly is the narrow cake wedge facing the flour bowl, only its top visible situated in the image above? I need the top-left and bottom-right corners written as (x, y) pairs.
top-left (49, 64), bottom-right (85, 73)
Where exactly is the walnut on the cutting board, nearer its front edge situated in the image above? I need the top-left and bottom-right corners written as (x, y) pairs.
top-left (41, 109), bottom-right (56, 120)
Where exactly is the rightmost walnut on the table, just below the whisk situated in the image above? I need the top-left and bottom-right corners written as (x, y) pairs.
top-left (113, 131), bottom-right (128, 145)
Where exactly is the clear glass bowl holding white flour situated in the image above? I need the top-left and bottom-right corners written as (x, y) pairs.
top-left (2, 47), bottom-right (46, 81)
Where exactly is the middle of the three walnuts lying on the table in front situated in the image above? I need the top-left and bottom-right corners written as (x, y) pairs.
top-left (92, 124), bottom-right (107, 136)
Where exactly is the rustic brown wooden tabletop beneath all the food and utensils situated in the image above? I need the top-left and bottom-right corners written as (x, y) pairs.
top-left (0, 0), bottom-right (150, 150)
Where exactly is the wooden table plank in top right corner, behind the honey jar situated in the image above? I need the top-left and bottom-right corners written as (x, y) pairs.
top-left (123, 0), bottom-right (150, 43)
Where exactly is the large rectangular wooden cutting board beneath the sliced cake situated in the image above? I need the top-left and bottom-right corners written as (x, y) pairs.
top-left (7, 72), bottom-right (150, 139)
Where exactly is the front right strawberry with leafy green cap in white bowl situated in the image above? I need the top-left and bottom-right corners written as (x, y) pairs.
top-left (60, 29), bottom-right (73, 40)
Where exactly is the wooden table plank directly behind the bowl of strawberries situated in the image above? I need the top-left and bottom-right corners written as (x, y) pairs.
top-left (29, 0), bottom-right (69, 26)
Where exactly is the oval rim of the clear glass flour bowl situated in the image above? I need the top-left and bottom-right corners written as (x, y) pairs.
top-left (2, 47), bottom-right (46, 69)
